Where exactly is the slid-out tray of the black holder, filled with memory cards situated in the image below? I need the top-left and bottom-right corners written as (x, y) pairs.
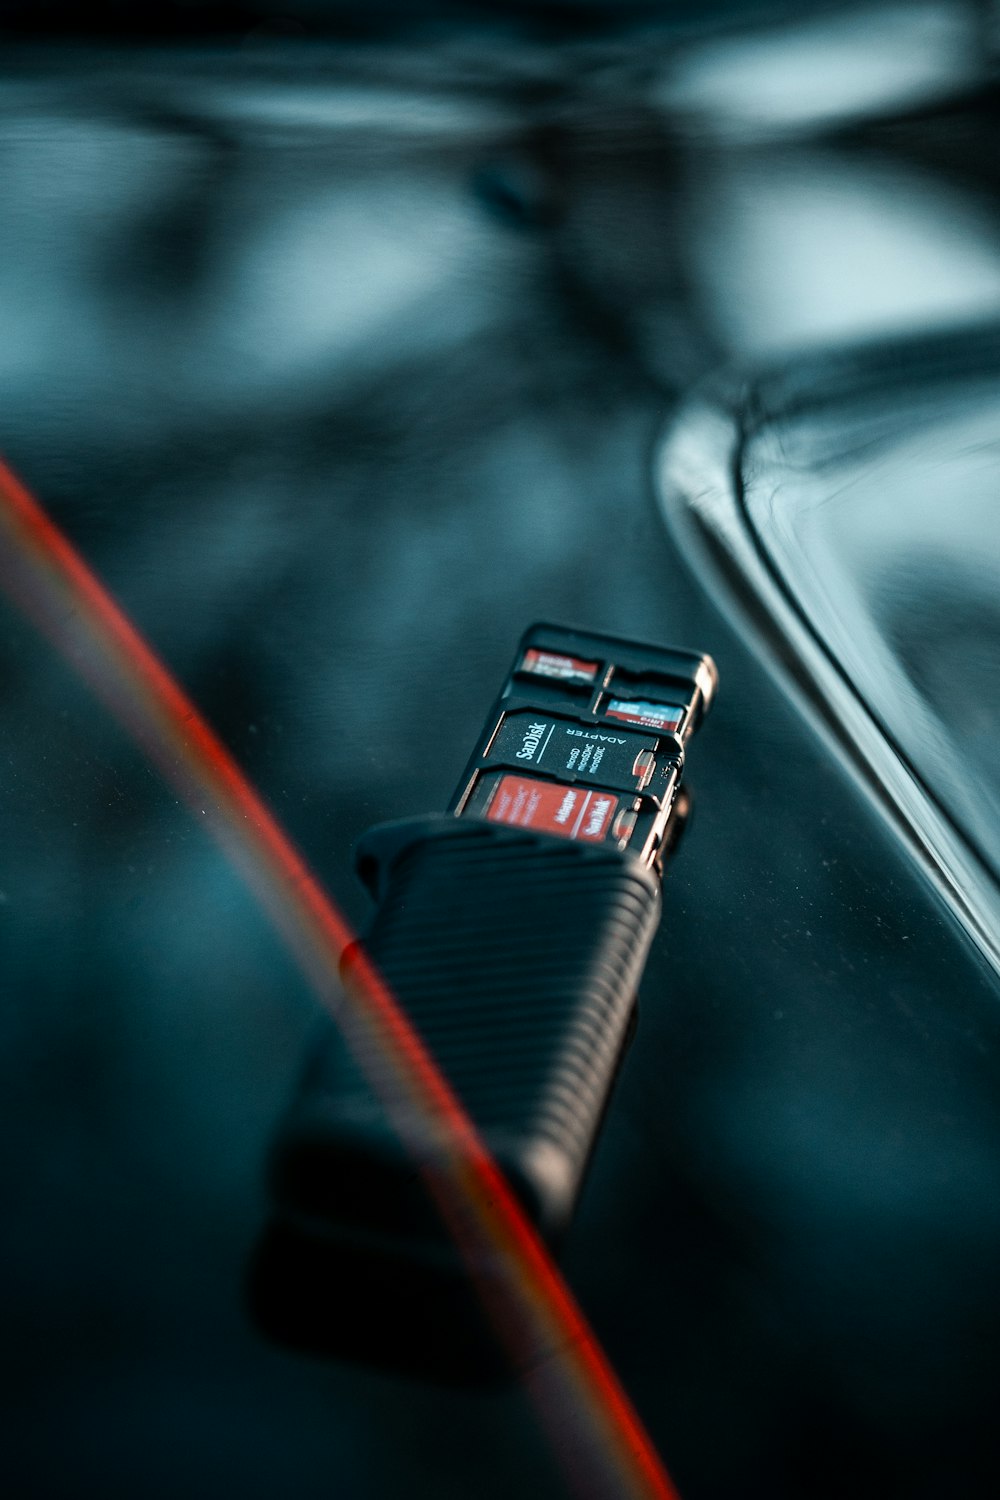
top-left (451, 624), bottom-right (717, 864)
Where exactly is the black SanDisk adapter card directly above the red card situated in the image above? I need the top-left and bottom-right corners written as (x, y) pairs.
top-left (486, 710), bottom-right (657, 792)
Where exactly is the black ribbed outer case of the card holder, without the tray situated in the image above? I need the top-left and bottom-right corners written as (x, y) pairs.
top-left (269, 819), bottom-right (660, 1244)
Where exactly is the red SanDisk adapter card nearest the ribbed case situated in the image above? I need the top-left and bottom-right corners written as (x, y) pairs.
top-left (469, 773), bottom-right (634, 843)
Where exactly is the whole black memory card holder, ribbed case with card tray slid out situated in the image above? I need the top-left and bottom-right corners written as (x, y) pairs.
top-left (250, 626), bottom-right (715, 1382)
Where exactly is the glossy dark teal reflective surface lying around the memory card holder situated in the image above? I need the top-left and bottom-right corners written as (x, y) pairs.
top-left (0, 12), bottom-right (1000, 1500)
